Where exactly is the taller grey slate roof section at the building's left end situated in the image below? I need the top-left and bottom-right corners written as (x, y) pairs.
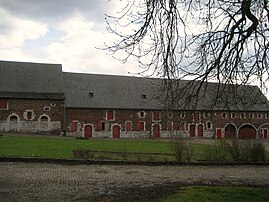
top-left (0, 61), bottom-right (64, 99)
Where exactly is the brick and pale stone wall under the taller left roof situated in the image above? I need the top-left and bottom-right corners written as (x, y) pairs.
top-left (0, 99), bottom-right (63, 133)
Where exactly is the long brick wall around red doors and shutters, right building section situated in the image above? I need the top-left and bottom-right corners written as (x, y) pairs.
top-left (66, 109), bottom-right (269, 138)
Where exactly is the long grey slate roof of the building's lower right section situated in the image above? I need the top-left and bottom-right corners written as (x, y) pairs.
top-left (63, 73), bottom-right (269, 111)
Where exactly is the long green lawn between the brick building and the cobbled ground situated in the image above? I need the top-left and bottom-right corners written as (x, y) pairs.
top-left (0, 134), bottom-right (269, 161)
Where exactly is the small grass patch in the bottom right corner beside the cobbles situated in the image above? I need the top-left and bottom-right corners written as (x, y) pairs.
top-left (160, 186), bottom-right (269, 202)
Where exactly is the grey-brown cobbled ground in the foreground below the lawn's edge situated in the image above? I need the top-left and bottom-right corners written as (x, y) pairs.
top-left (0, 162), bottom-right (269, 202)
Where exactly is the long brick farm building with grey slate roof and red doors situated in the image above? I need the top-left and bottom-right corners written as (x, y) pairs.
top-left (0, 61), bottom-right (269, 139)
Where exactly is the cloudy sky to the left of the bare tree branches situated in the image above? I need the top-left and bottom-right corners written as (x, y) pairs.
top-left (0, 0), bottom-right (139, 75)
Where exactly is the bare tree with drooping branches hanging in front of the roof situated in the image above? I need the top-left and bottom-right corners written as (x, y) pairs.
top-left (107, 0), bottom-right (269, 108)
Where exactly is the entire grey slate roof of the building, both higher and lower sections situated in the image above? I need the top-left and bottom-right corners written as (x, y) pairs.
top-left (0, 61), bottom-right (269, 112)
